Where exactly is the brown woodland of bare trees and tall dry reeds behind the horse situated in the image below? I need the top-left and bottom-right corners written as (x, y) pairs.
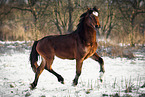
top-left (0, 0), bottom-right (145, 46)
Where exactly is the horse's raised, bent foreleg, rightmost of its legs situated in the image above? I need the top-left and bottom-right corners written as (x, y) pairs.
top-left (91, 53), bottom-right (105, 73)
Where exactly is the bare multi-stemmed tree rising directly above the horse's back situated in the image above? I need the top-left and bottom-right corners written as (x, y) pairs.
top-left (52, 0), bottom-right (82, 34)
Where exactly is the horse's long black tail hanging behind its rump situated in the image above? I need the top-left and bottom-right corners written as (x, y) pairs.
top-left (30, 41), bottom-right (39, 72)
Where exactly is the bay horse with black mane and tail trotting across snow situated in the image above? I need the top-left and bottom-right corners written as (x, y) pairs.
top-left (30, 7), bottom-right (105, 89)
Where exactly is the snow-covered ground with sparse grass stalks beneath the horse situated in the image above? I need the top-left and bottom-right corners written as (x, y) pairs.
top-left (0, 42), bottom-right (145, 97)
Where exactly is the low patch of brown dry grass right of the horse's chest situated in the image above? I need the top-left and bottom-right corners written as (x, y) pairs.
top-left (98, 41), bottom-right (135, 59)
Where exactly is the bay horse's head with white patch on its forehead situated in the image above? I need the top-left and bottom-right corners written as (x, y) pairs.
top-left (86, 7), bottom-right (100, 28)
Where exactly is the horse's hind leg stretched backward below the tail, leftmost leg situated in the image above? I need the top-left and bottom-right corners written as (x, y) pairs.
top-left (31, 59), bottom-right (46, 89)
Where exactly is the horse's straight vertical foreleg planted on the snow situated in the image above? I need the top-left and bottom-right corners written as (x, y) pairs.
top-left (73, 60), bottom-right (83, 86)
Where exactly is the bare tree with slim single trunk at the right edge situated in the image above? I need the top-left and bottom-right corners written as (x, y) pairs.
top-left (117, 0), bottom-right (145, 46)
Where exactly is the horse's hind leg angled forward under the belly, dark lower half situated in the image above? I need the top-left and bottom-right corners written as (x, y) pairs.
top-left (45, 57), bottom-right (64, 84)
